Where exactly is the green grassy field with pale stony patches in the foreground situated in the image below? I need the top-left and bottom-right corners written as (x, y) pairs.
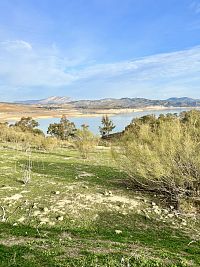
top-left (0, 144), bottom-right (200, 267)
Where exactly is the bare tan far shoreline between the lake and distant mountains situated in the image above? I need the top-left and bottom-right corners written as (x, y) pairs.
top-left (0, 106), bottom-right (200, 122)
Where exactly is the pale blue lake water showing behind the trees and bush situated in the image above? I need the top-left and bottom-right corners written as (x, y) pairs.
top-left (37, 108), bottom-right (197, 134)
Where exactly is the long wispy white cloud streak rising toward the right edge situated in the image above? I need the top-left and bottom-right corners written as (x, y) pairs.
top-left (77, 46), bottom-right (200, 81)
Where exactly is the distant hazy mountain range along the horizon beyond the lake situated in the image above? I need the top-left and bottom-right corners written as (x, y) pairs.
top-left (16, 96), bottom-right (200, 109)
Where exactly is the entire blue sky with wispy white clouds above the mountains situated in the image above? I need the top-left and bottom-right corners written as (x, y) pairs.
top-left (0, 0), bottom-right (200, 101)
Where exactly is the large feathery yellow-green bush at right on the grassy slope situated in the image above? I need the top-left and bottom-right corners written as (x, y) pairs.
top-left (112, 110), bottom-right (200, 205)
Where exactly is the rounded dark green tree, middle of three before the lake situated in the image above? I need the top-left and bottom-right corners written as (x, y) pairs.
top-left (47, 116), bottom-right (77, 140)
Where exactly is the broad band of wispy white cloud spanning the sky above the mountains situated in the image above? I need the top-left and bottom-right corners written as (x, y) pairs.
top-left (0, 40), bottom-right (200, 98)
